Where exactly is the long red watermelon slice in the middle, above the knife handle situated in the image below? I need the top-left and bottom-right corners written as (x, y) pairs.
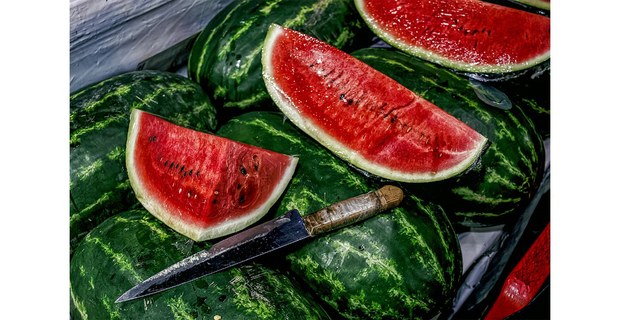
top-left (262, 24), bottom-right (487, 182)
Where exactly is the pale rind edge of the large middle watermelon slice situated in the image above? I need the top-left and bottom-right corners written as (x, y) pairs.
top-left (262, 24), bottom-right (489, 183)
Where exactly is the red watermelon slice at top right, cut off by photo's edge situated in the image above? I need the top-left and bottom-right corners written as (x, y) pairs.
top-left (355, 0), bottom-right (551, 74)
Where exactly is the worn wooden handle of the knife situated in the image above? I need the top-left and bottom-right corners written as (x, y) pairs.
top-left (303, 185), bottom-right (403, 237)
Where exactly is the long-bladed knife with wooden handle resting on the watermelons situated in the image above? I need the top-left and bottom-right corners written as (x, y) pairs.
top-left (116, 185), bottom-right (403, 303)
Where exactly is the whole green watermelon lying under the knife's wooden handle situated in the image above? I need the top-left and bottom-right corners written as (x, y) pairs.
top-left (217, 112), bottom-right (462, 319)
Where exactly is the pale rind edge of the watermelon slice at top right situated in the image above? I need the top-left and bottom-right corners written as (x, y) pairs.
top-left (355, 0), bottom-right (551, 74)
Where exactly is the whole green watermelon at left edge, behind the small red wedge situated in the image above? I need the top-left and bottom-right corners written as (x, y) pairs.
top-left (69, 71), bottom-right (217, 250)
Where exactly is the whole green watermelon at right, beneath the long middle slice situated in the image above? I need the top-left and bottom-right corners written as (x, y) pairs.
top-left (353, 48), bottom-right (544, 228)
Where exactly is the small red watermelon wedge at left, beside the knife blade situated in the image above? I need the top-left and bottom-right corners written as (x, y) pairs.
top-left (126, 109), bottom-right (298, 241)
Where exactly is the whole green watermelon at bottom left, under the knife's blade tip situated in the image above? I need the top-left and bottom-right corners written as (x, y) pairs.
top-left (69, 210), bottom-right (328, 320)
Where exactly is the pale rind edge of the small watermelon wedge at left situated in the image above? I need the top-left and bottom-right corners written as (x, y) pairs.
top-left (125, 109), bottom-right (299, 241)
